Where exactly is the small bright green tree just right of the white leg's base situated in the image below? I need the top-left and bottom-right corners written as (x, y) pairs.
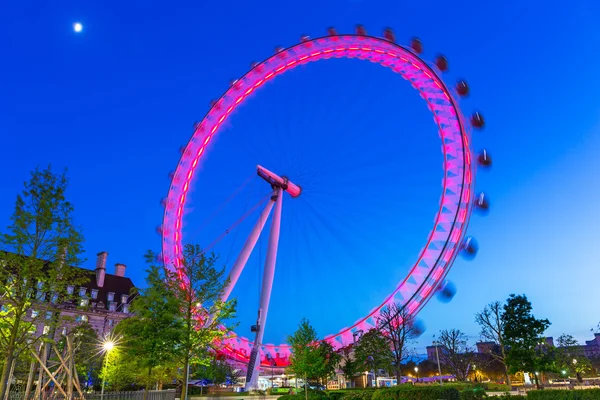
top-left (288, 318), bottom-right (325, 399)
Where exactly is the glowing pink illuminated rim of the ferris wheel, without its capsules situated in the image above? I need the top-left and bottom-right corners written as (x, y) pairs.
top-left (162, 34), bottom-right (474, 365)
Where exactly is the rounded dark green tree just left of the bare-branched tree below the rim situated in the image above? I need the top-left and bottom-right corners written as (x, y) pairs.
top-left (354, 329), bottom-right (394, 379)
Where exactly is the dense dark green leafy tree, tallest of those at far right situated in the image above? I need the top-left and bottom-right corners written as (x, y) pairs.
top-left (502, 294), bottom-right (550, 387)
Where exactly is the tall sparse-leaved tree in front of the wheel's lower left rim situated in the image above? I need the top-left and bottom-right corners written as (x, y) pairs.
top-left (167, 244), bottom-right (236, 399)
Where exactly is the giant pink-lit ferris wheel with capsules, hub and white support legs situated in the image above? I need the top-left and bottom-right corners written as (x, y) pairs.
top-left (161, 26), bottom-right (492, 388)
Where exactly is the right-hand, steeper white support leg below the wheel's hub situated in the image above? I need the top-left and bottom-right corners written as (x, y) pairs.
top-left (246, 188), bottom-right (283, 390)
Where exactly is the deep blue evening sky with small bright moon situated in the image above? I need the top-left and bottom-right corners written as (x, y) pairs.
top-left (0, 0), bottom-right (600, 349)
